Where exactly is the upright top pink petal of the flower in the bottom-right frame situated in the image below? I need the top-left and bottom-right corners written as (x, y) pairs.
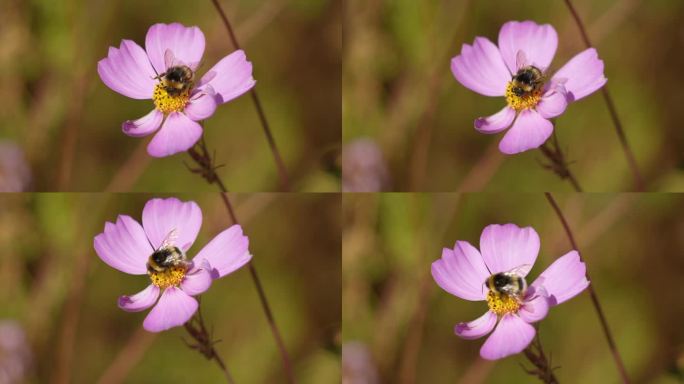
top-left (480, 224), bottom-right (539, 281)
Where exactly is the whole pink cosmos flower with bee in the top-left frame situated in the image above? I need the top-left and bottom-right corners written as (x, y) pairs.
top-left (97, 23), bottom-right (256, 157)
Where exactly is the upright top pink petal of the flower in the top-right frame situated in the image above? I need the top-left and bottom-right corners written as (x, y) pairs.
top-left (499, 21), bottom-right (558, 73)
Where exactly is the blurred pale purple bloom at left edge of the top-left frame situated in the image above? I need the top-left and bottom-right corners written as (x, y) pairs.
top-left (0, 141), bottom-right (31, 192)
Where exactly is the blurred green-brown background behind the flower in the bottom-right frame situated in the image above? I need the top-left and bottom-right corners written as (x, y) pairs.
top-left (342, 193), bottom-right (684, 384)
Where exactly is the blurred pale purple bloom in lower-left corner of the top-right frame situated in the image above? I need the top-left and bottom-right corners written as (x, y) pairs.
top-left (342, 139), bottom-right (389, 192)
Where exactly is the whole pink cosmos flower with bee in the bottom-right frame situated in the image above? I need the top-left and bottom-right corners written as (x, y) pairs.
top-left (432, 224), bottom-right (589, 360)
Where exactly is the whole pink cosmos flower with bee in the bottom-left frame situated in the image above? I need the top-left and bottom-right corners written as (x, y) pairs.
top-left (94, 198), bottom-right (252, 332)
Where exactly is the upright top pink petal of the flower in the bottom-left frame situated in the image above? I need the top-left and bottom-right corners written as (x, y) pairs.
top-left (143, 197), bottom-right (202, 252)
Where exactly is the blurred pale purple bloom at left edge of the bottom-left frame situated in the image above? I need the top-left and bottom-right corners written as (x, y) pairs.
top-left (0, 320), bottom-right (32, 384)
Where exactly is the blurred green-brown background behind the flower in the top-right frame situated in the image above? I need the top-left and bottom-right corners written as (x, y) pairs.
top-left (342, 0), bottom-right (684, 192)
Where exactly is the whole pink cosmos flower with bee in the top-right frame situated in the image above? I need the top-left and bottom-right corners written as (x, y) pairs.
top-left (451, 21), bottom-right (608, 154)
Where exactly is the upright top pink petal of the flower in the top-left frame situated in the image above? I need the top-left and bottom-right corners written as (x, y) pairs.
top-left (145, 23), bottom-right (205, 74)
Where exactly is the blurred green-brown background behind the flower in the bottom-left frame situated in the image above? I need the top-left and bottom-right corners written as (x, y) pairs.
top-left (0, 193), bottom-right (341, 383)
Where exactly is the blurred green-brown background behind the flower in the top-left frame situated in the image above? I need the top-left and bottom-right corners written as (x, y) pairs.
top-left (0, 0), bottom-right (342, 192)
